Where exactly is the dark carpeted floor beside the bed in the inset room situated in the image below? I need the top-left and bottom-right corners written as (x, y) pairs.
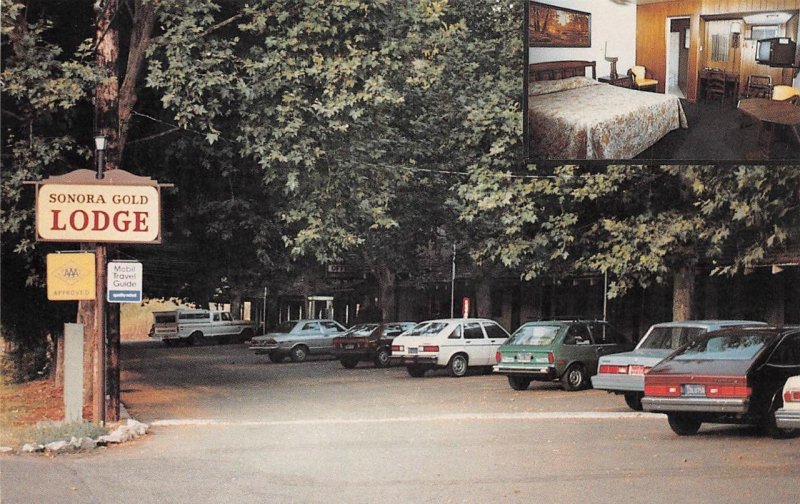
top-left (636, 100), bottom-right (800, 161)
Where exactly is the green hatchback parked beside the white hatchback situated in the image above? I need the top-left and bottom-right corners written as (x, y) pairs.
top-left (493, 320), bottom-right (634, 390)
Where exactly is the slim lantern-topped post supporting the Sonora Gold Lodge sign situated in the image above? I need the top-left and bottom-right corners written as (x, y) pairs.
top-left (92, 135), bottom-right (107, 426)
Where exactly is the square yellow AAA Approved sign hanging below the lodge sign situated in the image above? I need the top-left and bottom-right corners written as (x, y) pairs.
top-left (47, 252), bottom-right (96, 301)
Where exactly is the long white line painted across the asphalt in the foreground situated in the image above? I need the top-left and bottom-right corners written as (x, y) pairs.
top-left (150, 411), bottom-right (664, 427)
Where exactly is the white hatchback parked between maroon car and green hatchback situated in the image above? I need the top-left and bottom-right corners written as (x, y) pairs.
top-left (392, 318), bottom-right (508, 378)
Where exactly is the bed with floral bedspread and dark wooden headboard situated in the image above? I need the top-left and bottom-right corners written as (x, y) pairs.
top-left (527, 61), bottom-right (688, 160)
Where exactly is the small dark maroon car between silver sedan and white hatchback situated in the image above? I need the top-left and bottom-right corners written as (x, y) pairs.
top-left (333, 322), bottom-right (417, 369)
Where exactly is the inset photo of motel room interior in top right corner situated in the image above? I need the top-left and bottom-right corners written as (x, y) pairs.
top-left (526, 0), bottom-right (800, 163)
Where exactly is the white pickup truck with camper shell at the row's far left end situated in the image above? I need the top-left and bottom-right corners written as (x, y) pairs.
top-left (150, 309), bottom-right (258, 346)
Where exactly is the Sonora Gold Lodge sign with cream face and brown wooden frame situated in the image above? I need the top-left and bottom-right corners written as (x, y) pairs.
top-left (36, 170), bottom-right (161, 243)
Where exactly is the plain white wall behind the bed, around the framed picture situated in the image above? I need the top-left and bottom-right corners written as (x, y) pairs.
top-left (528, 0), bottom-right (636, 77)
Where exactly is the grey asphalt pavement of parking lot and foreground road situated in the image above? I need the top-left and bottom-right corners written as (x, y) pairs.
top-left (2, 342), bottom-right (800, 503)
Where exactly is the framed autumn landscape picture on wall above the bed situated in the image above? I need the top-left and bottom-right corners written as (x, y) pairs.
top-left (528, 2), bottom-right (592, 47)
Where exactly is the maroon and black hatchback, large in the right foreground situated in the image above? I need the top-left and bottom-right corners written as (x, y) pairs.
top-left (642, 326), bottom-right (800, 437)
